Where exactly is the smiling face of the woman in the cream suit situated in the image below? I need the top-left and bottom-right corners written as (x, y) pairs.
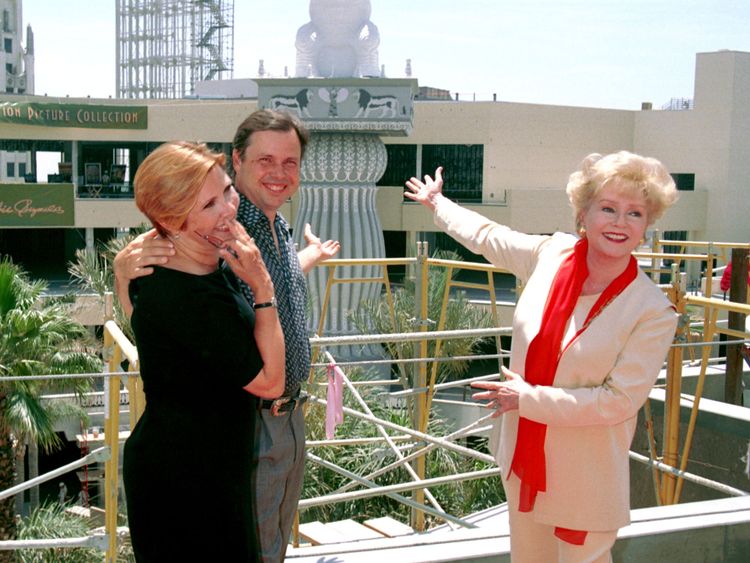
top-left (580, 181), bottom-right (648, 268)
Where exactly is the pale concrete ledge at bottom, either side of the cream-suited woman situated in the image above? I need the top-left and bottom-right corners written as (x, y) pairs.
top-left (287, 496), bottom-right (750, 563)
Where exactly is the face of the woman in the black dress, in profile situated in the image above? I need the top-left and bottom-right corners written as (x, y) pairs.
top-left (181, 166), bottom-right (240, 250)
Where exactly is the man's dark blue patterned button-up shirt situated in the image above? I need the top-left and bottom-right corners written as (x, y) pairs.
top-left (237, 194), bottom-right (310, 395)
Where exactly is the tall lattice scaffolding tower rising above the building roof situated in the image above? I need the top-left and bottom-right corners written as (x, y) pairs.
top-left (116, 0), bottom-right (234, 98)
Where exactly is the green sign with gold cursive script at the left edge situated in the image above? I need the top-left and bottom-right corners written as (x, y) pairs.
top-left (0, 184), bottom-right (75, 228)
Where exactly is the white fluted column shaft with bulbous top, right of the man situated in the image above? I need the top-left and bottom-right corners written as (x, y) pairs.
top-left (294, 132), bottom-right (387, 342)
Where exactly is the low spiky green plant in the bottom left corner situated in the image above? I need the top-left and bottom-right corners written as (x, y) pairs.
top-left (18, 503), bottom-right (104, 563)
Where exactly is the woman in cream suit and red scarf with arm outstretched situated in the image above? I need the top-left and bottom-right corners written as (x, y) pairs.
top-left (406, 151), bottom-right (677, 563)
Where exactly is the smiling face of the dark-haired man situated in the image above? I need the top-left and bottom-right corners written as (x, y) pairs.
top-left (232, 130), bottom-right (302, 223)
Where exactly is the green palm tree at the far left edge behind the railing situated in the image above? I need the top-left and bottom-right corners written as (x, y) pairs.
top-left (0, 258), bottom-right (101, 560)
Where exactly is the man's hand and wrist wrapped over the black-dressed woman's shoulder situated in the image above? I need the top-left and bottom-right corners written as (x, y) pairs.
top-left (112, 229), bottom-right (174, 318)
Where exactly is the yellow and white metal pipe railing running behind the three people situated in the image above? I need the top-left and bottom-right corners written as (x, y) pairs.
top-left (0, 247), bottom-right (750, 562)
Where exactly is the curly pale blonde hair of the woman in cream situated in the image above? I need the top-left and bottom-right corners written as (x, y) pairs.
top-left (565, 151), bottom-right (677, 228)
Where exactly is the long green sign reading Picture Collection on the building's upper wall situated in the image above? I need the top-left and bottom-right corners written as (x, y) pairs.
top-left (0, 102), bottom-right (148, 129)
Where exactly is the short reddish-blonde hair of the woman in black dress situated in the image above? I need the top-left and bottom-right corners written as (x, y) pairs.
top-left (133, 141), bottom-right (226, 236)
